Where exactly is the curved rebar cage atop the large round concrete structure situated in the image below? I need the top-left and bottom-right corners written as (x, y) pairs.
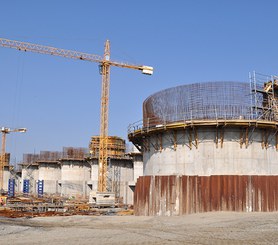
top-left (143, 81), bottom-right (254, 127)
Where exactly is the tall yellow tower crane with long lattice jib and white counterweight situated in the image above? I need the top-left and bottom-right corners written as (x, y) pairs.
top-left (0, 38), bottom-right (153, 192)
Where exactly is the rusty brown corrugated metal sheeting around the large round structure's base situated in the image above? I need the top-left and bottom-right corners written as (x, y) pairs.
top-left (134, 175), bottom-right (278, 215)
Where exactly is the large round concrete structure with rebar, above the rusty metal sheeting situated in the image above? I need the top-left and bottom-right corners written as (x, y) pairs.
top-left (129, 82), bottom-right (278, 176)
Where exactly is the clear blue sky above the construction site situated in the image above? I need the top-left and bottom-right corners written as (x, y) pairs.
top-left (0, 0), bottom-right (278, 161)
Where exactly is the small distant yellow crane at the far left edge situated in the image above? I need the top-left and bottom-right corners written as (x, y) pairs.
top-left (0, 127), bottom-right (27, 191)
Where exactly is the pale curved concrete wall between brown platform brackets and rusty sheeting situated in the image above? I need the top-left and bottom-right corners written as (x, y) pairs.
top-left (143, 127), bottom-right (278, 176)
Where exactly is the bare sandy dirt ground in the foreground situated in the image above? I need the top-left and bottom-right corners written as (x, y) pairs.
top-left (0, 212), bottom-right (278, 245)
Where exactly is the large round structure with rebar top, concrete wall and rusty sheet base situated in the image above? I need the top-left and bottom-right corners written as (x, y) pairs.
top-left (129, 80), bottom-right (278, 215)
